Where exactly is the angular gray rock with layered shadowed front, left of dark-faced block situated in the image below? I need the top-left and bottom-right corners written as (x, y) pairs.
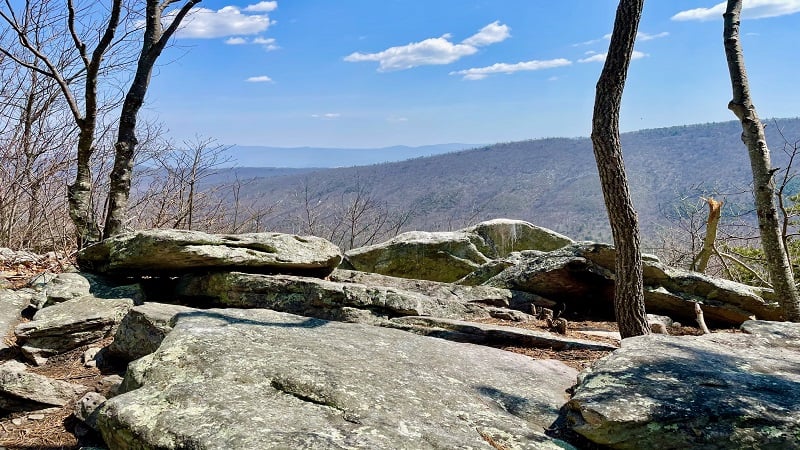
top-left (14, 296), bottom-right (133, 364)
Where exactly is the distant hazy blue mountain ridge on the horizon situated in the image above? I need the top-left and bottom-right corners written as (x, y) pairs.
top-left (222, 144), bottom-right (478, 168)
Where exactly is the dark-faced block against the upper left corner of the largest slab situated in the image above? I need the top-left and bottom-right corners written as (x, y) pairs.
top-left (108, 303), bottom-right (194, 361)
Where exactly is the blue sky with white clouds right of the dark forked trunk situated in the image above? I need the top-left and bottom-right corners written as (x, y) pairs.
top-left (145, 0), bottom-right (800, 148)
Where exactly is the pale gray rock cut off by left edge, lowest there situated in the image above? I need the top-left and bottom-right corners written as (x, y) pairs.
top-left (0, 361), bottom-right (89, 411)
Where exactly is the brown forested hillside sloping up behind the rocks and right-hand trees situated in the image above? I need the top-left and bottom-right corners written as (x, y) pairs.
top-left (216, 119), bottom-right (800, 248)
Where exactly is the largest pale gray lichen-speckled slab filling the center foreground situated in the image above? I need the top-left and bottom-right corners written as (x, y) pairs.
top-left (98, 309), bottom-right (576, 449)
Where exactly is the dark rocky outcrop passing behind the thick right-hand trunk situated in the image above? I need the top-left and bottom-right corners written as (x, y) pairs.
top-left (485, 243), bottom-right (782, 326)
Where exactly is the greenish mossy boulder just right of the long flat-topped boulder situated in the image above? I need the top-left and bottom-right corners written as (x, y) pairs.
top-left (345, 231), bottom-right (489, 283)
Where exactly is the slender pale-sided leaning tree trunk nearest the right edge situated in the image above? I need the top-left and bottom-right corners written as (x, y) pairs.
top-left (723, 0), bottom-right (800, 322)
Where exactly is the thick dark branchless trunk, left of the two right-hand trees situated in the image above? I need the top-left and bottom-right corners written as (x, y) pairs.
top-left (592, 0), bottom-right (650, 338)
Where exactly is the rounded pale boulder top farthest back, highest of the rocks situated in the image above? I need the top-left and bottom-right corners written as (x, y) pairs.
top-left (461, 219), bottom-right (575, 259)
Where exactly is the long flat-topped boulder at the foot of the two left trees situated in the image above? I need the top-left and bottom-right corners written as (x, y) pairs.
top-left (77, 230), bottom-right (342, 276)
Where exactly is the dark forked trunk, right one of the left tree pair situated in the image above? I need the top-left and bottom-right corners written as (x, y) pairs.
top-left (103, 0), bottom-right (201, 237)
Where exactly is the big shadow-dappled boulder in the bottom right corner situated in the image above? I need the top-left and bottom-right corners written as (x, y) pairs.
top-left (568, 322), bottom-right (800, 449)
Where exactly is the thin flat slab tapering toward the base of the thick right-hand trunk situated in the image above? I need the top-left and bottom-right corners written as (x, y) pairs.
top-left (392, 317), bottom-right (618, 351)
